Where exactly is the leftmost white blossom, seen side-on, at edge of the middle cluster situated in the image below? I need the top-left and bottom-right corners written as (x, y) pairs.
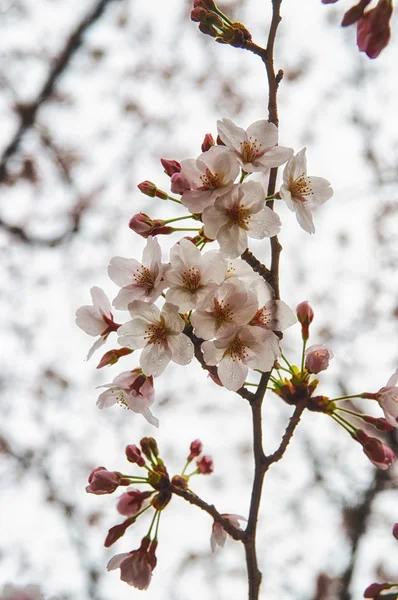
top-left (76, 287), bottom-right (120, 360)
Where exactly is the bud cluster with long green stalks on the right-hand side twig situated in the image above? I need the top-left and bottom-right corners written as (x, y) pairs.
top-left (271, 302), bottom-right (398, 470)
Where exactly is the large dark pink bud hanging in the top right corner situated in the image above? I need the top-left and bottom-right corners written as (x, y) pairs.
top-left (357, 0), bottom-right (393, 58)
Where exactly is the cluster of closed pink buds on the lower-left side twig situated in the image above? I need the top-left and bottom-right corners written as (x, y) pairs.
top-left (86, 438), bottom-right (216, 590)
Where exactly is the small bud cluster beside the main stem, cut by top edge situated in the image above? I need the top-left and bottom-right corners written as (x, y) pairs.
top-left (191, 0), bottom-right (252, 48)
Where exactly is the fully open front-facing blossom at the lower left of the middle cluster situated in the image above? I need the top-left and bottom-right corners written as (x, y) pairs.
top-left (118, 300), bottom-right (194, 377)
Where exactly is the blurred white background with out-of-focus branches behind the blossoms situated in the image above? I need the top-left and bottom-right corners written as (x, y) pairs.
top-left (0, 0), bottom-right (398, 600)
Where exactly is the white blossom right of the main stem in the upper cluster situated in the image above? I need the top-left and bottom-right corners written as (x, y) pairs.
top-left (279, 148), bottom-right (333, 233)
